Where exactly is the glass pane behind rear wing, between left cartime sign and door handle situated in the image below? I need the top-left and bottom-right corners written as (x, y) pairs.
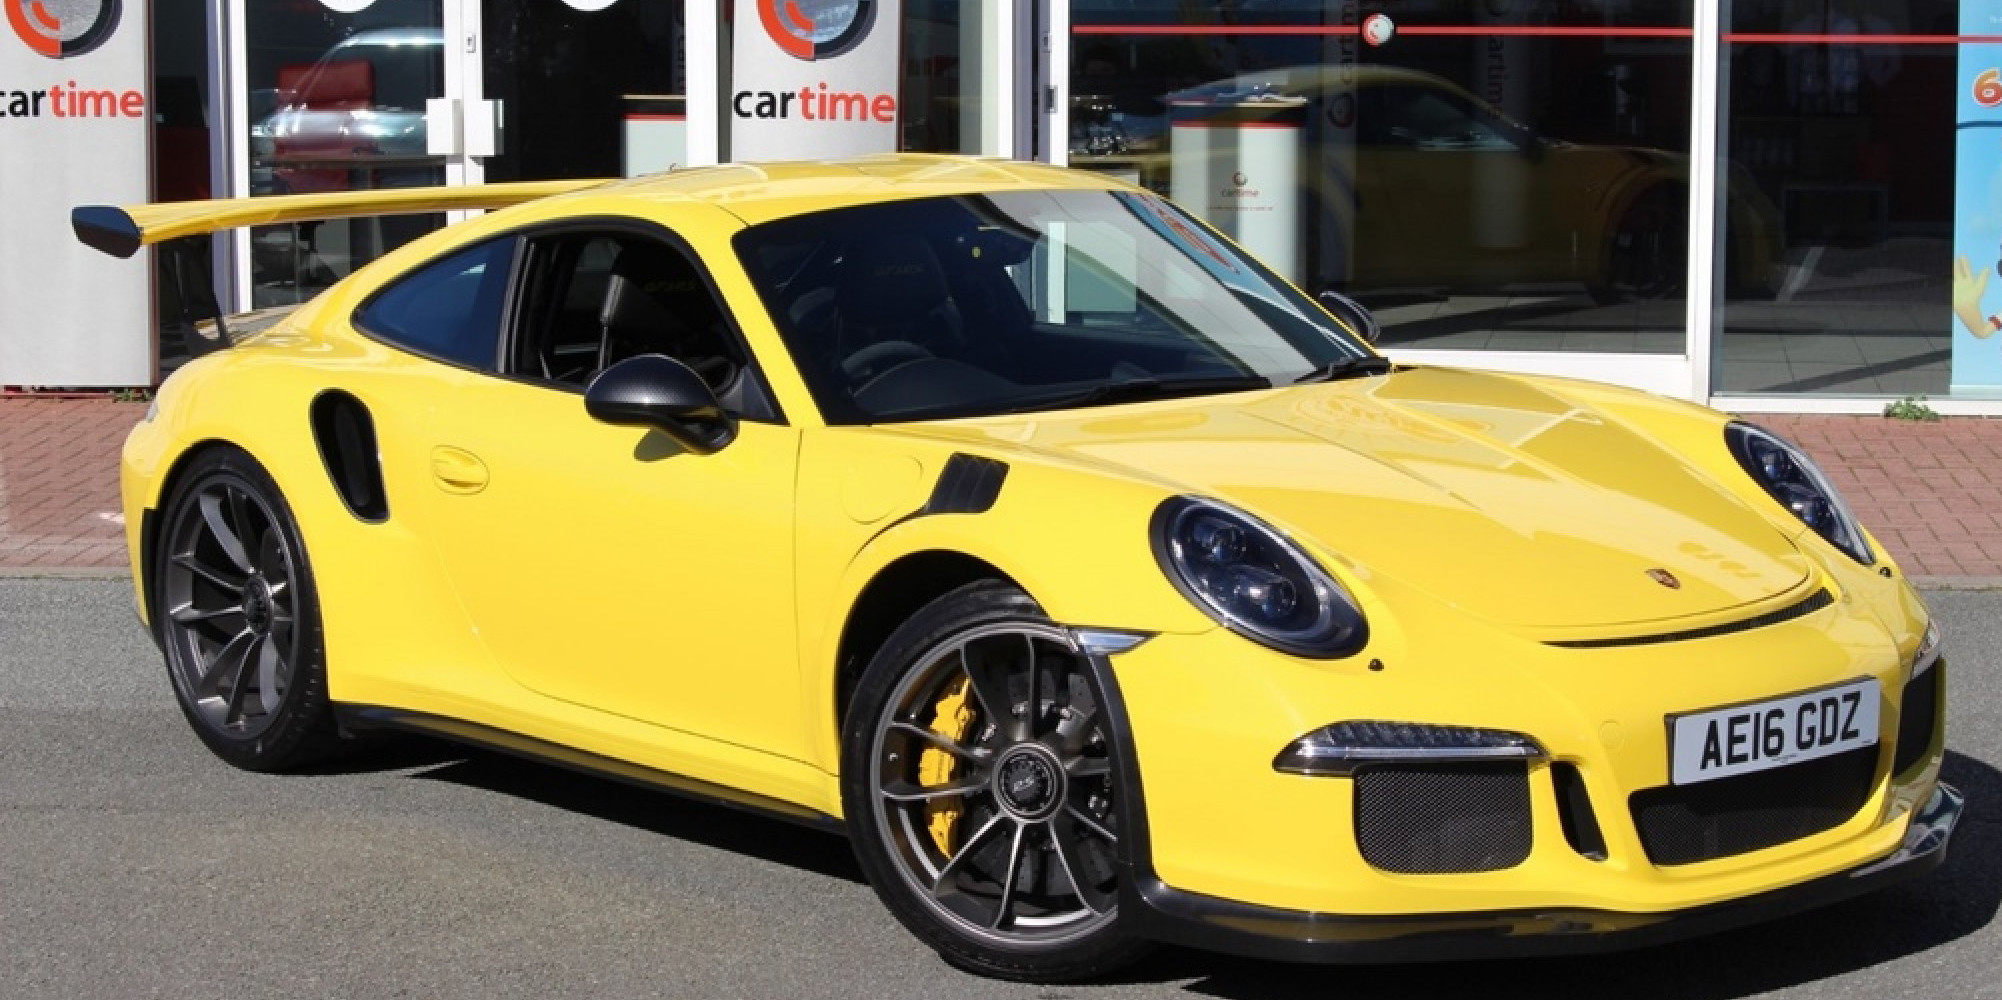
top-left (244, 0), bottom-right (444, 308)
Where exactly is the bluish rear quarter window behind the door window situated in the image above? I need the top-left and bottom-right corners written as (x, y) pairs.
top-left (354, 238), bottom-right (515, 368)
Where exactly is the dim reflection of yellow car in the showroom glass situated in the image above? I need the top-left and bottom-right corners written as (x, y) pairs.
top-left (1071, 66), bottom-right (1780, 302)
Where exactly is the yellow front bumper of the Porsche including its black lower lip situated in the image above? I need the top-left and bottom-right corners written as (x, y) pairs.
top-left (1103, 572), bottom-right (1960, 962)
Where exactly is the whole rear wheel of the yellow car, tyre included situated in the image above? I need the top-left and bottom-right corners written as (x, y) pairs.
top-left (152, 448), bottom-right (340, 770)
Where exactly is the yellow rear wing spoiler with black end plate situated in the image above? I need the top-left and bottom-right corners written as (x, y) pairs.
top-left (70, 180), bottom-right (605, 258)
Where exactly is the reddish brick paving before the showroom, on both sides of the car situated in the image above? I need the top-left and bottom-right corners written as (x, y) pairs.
top-left (0, 396), bottom-right (2002, 584)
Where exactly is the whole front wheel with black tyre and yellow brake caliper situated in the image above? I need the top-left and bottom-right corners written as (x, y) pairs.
top-left (841, 580), bottom-right (1149, 982)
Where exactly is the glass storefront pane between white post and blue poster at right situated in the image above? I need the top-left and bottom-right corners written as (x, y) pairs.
top-left (1714, 0), bottom-right (1953, 396)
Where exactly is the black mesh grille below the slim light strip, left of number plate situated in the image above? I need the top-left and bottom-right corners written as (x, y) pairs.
top-left (1355, 762), bottom-right (1530, 874)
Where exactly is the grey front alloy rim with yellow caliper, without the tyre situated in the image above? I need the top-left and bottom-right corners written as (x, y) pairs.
top-left (869, 622), bottom-right (1119, 950)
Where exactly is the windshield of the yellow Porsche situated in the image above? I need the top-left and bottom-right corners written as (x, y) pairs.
top-left (737, 190), bottom-right (1371, 424)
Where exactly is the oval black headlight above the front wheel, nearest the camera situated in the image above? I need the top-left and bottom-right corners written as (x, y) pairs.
top-left (1153, 496), bottom-right (1369, 660)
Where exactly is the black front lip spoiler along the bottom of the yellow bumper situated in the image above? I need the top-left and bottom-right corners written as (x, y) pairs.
top-left (1121, 784), bottom-right (1964, 964)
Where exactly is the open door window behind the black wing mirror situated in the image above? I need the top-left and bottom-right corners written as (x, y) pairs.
top-left (513, 232), bottom-right (773, 418)
